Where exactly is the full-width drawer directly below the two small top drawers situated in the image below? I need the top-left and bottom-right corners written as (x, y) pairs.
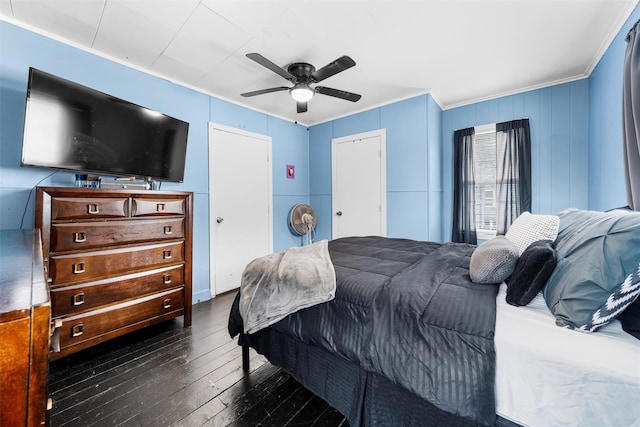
top-left (50, 218), bottom-right (184, 252)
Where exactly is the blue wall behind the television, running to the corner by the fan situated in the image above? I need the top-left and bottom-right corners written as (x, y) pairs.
top-left (0, 21), bottom-right (309, 302)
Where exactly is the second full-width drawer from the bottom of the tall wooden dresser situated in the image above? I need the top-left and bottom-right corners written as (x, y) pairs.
top-left (51, 265), bottom-right (184, 317)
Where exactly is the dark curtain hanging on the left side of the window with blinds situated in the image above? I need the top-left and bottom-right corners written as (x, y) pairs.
top-left (451, 128), bottom-right (478, 245)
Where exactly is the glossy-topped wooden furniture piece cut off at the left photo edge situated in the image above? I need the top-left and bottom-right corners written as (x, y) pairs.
top-left (0, 230), bottom-right (51, 426)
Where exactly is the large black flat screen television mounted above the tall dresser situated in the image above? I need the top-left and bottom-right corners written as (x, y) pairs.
top-left (20, 68), bottom-right (189, 182)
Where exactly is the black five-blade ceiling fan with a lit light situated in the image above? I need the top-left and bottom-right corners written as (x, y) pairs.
top-left (240, 53), bottom-right (362, 113)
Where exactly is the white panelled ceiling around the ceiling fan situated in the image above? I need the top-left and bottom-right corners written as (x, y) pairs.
top-left (0, 0), bottom-right (638, 125)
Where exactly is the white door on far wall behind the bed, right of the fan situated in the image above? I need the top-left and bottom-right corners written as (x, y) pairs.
top-left (331, 129), bottom-right (387, 239)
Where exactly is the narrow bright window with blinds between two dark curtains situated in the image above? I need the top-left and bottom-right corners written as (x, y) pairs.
top-left (473, 124), bottom-right (498, 240)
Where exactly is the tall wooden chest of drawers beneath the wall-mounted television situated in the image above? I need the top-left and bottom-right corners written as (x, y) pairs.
top-left (36, 187), bottom-right (193, 360)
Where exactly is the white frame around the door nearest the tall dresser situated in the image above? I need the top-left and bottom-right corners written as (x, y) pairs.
top-left (207, 122), bottom-right (273, 298)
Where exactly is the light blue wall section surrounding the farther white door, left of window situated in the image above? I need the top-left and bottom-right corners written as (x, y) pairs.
top-left (309, 94), bottom-right (443, 241)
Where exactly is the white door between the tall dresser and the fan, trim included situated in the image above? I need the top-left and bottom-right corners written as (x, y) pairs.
top-left (209, 123), bottom-right (273, 296)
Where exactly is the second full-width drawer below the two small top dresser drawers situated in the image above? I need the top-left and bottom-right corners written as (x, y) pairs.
top-left (49, 241), bottom-right (184, 285)
